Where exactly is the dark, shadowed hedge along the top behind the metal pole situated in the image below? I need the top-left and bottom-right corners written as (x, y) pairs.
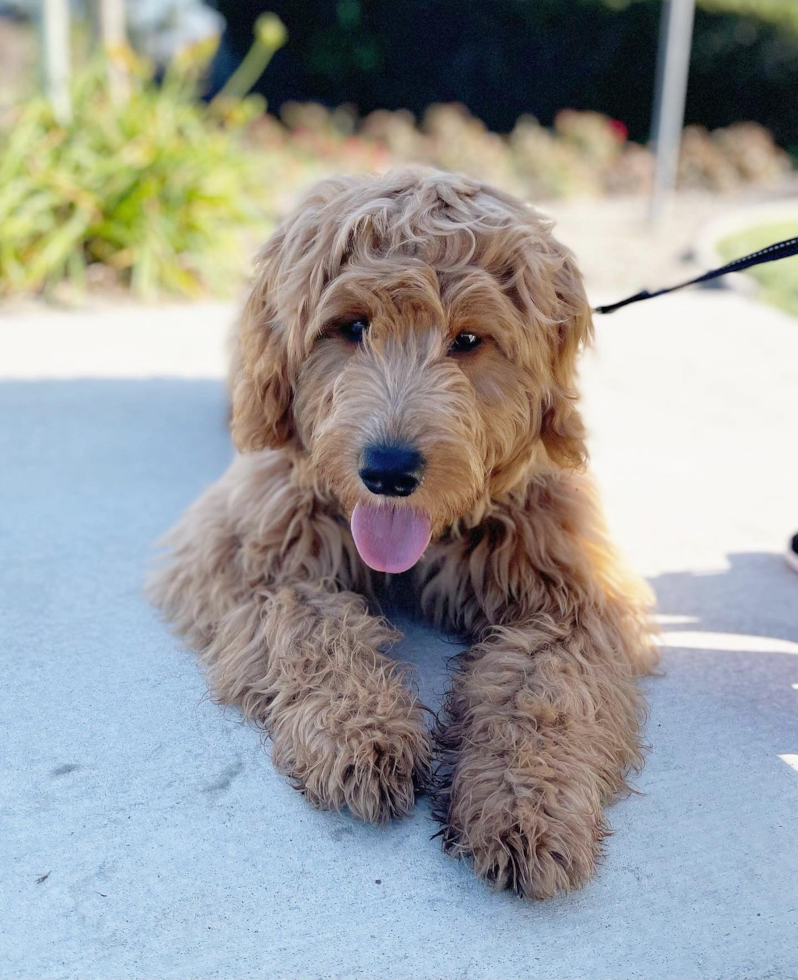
top-left (215, 0), bottom-right (798, 157)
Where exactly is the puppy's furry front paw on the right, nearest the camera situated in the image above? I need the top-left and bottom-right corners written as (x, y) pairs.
top-left (442, 757), bottom-right (607, 899)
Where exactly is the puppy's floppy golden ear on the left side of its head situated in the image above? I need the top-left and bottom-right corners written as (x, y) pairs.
top-left (231, 239), bottom-right (293, 452)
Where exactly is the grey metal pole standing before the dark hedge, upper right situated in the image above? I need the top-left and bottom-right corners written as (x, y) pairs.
top-left (649, 0), bottom-right (695, 224)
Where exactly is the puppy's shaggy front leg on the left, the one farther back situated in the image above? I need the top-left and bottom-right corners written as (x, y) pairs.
top-left (203, 583), bottom-right (430, 822)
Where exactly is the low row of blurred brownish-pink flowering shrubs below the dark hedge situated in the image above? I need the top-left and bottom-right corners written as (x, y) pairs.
top-left (268, 102), bottom-right (791, 200)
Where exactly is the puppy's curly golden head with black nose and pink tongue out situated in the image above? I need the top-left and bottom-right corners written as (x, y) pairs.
top-left (233, 171), bottom-right (591, 571)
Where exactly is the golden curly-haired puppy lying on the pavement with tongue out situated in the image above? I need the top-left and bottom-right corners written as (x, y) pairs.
top-left (152, 170), bottom-right (655, 898)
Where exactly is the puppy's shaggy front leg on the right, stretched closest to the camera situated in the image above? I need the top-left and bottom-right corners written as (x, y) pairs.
top-left (438, 609), bottom-right (641, 898)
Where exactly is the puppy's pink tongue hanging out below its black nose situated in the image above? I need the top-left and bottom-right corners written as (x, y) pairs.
top-left (352, 503), bottom-right (431, 572)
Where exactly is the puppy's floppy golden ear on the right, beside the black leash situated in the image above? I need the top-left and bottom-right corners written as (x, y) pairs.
top-left (540, 239), bottom-right (593, 466)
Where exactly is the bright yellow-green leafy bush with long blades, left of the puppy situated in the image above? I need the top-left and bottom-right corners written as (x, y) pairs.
top-left (0, 64), bottom-right (263, 298)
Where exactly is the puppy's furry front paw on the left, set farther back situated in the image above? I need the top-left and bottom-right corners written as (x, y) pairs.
top-left (271, 698), bottom-right (430, 823)
